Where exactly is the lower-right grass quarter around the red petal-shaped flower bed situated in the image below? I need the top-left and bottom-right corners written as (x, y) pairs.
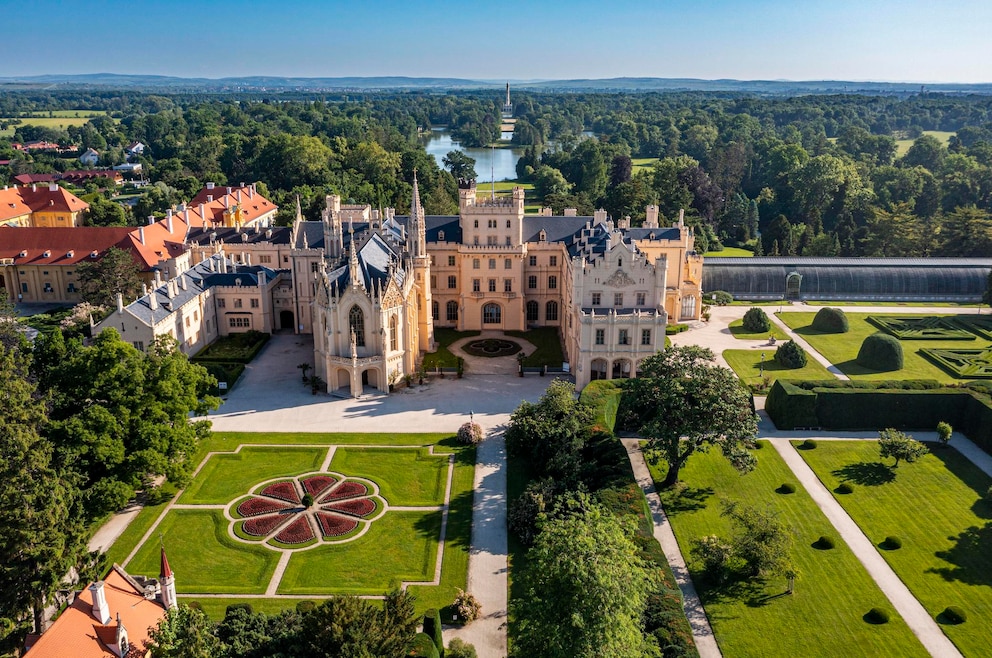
top-left (278, 512), bottom-right (441, 595)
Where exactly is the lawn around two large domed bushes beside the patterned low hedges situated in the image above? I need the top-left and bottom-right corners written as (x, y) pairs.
top-left (778, 312), bottom-right (990, 383)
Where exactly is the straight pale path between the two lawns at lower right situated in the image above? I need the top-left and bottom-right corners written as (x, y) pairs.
top-left (771, 437), bottom-right (961, 658)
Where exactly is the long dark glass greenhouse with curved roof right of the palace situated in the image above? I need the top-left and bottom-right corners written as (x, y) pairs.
top-left (703, 256), bottom-right (992, 302)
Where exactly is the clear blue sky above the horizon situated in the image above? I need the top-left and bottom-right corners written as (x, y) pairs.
top-left (0, 0), bottom-right (992, 83)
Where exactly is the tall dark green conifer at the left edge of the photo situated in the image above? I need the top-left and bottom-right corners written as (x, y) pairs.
top-left (0, 345), bottom-right (86, 633)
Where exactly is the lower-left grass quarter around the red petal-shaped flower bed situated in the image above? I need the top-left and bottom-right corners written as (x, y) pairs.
top-left (124, 509), bottom-right (279, 594)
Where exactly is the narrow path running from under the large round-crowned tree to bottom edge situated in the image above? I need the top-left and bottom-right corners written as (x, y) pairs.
top-left (621, 439), bottom-right (722, 658)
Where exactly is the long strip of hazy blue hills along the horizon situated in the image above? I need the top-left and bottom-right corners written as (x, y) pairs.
top-left (0, 73), bottom-right (992, 96)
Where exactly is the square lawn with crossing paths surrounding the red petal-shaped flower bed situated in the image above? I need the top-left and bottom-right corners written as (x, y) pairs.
top-left (108, 434), bottom-right (475, 617)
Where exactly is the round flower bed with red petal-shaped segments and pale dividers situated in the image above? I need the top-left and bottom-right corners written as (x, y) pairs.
top-left (228, 473), bottom-right (386, 549)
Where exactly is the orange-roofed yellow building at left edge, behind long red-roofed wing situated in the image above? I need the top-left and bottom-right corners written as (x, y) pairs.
top-left (0, 182), bottom-right (90, 228)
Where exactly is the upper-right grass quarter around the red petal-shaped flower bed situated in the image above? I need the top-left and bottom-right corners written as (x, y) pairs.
top-left (331, 448), bottom-right (448, 507)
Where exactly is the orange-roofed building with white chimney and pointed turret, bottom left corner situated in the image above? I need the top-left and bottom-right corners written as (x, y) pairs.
top-left (25, 548), bottom-right (176, 658)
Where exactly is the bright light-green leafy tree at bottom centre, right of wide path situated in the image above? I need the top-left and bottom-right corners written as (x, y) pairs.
top-left (510, 494), bottom-right (652, 658)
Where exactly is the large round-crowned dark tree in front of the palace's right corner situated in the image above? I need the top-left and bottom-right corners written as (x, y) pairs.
top-left (621, 345), bottom-right (758, 487)
